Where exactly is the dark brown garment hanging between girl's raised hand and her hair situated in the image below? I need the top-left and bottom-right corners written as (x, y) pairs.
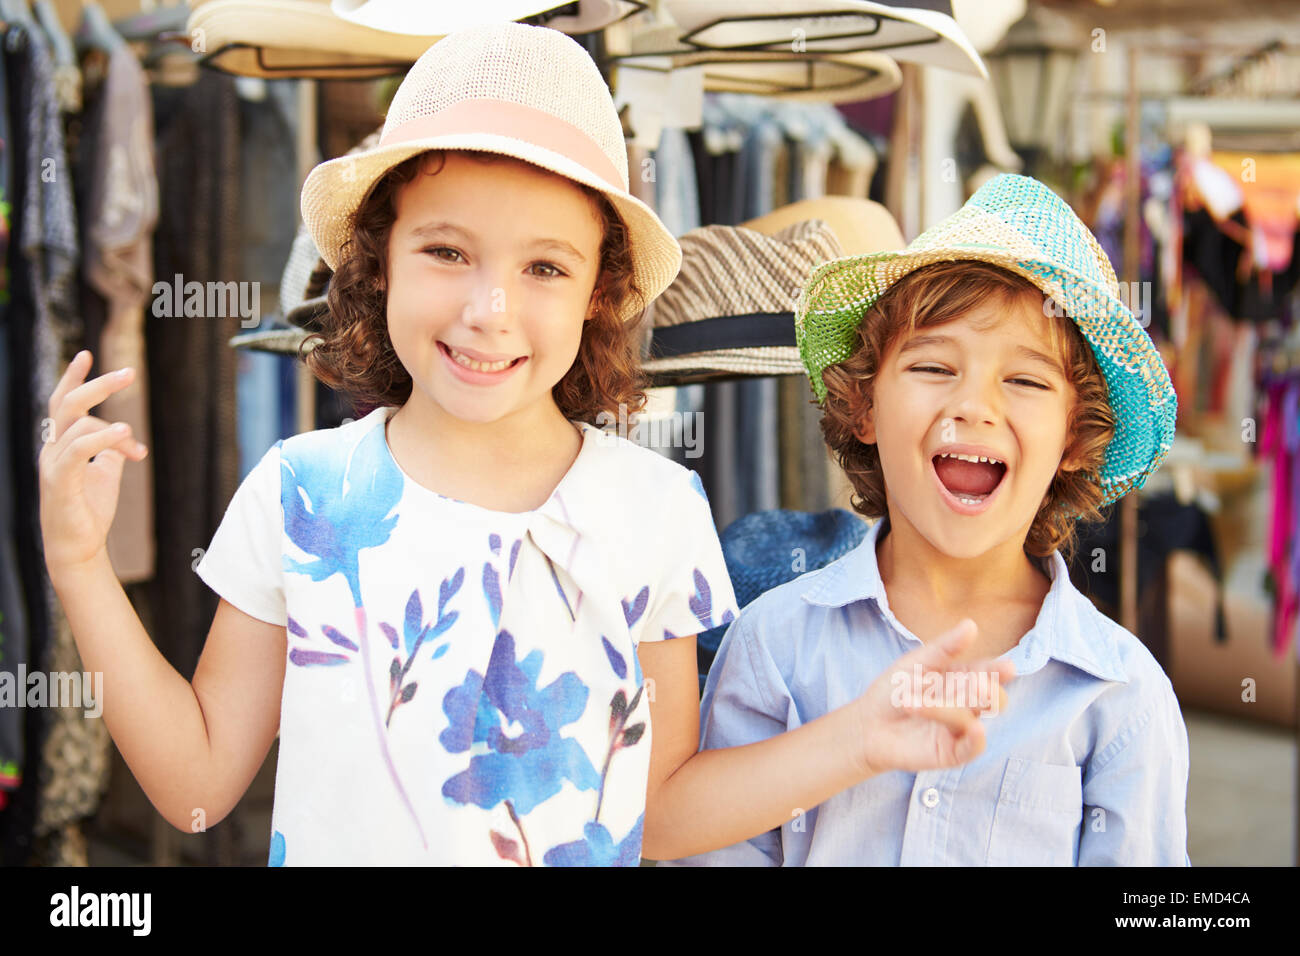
top-left (146, 70), bottom-right (239, 680)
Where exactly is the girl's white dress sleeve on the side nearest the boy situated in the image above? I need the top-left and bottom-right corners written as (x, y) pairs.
top-left (638, 470), bottom-right (740, 641)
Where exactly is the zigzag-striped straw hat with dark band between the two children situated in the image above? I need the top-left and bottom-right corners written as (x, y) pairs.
top-left (644, 219), bottom-right (842, 385)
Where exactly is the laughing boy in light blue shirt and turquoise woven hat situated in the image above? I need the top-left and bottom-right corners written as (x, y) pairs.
top-left (680, 176), bottom-right (1190, 865)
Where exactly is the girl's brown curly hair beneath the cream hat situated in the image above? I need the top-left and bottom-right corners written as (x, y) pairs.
top-left (300, 150), bottom-right (646, 424)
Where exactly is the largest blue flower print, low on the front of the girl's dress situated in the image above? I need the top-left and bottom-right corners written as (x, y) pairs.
top-left (438, 631), bottom-right (601, 814)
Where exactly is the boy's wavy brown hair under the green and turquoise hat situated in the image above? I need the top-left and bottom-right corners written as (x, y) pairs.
top-left (822, 261), bottom-right (1115, 561)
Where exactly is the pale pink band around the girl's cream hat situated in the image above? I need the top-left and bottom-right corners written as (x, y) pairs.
top-left (380, 99), bottom-right (628, 191)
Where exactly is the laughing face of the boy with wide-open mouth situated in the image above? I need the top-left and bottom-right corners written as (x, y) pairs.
top-left (857, 295), bottom-right (1075, 558)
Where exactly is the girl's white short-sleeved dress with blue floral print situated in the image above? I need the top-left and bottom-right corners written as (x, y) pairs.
top-left (198, 407), bottom-right (737, 866)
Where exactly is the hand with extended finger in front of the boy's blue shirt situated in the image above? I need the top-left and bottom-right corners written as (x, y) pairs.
top-left (858, 618), bottom-right (1015, 775)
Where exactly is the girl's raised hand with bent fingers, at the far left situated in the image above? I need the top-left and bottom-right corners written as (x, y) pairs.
top-left (38, 351), bottom-right (148, 571)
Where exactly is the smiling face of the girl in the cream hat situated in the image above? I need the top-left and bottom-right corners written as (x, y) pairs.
top-left (387, 153), bottom-right (603, 424)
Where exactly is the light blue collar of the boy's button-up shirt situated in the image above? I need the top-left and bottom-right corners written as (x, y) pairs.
top-left (802, 519), bottom-right (1128, 683)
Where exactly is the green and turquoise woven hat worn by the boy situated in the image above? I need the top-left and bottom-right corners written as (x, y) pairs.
top-left (796, 173), bottom-right (1178, 505)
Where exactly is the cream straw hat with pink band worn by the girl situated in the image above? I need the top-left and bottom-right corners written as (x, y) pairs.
top-left (302, 17), bottom-right (681, 320)
